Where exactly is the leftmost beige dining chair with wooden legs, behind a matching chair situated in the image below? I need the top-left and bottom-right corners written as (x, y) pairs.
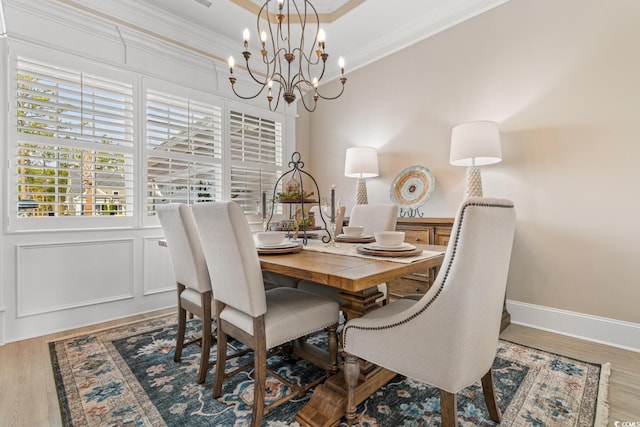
top-left (157, 203), bottom-right (214, 383)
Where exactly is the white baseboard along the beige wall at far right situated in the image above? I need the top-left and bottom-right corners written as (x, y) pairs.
top-left (507, 300), bottom-right (640, 352)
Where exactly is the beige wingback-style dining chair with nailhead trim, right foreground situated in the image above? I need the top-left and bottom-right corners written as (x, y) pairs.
top-left (342, 198), bottom-right (515, 426)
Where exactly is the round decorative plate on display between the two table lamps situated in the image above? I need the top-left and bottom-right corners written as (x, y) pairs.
top-left (389, 166), bottom-right (436, 210)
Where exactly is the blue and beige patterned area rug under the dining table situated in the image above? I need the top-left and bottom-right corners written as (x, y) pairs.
top-left (49, 315), bottom-right (609, 427)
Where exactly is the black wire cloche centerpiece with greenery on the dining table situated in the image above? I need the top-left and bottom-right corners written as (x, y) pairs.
top-left (267, 151), bottom-right (335, 245)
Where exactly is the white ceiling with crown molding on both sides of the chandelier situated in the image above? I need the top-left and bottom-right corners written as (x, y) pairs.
top-left (52, 0), bottom-right (508, 79)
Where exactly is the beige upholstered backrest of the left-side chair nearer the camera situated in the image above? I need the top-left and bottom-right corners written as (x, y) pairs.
top-left (192, 202), bottom-right (267, 317)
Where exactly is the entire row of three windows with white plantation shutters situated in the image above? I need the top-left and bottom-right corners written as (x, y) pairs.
top-left (9, 55), bottom-right (283, 231)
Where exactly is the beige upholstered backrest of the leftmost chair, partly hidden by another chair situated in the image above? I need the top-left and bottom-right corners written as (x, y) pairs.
top-left (157, 203), bottom-right (211, 293)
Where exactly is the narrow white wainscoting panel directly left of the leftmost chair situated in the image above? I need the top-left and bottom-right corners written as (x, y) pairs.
top-left (143, 237), bottom-right (176, 295)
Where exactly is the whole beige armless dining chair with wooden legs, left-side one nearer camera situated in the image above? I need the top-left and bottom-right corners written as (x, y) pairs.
top-left (192, 202), bottom-right (339, 426)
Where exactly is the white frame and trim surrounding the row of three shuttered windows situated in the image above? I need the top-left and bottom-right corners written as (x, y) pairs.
top-left (2, 42), bottom-right (295, 233)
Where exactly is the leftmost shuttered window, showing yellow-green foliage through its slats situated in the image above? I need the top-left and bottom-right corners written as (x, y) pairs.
top-left (16, 58), bottom-right (133, 217)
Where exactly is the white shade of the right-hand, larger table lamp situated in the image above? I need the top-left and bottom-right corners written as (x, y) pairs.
top-left (449, 121), bottom-right (502, 166)
